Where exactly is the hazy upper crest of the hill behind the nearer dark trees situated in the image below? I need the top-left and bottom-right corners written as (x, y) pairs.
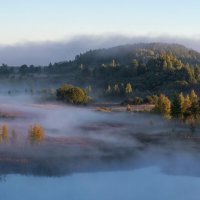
top-left (70, 43), bottom-right (200, 67)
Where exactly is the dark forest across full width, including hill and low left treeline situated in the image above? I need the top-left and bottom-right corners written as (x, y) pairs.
top-left (0, 43), bottom-right (200, 98)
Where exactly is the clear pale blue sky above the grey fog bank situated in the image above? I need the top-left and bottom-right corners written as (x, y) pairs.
top-left (0, 0), bottom-right (200, 45)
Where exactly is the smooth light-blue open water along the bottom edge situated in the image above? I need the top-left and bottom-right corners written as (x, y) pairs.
top-left (0, 167), bottom-right (200, 200)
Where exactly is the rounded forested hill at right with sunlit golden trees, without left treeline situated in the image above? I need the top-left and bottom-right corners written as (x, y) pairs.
top-left (54, 43), bottom-right (200, 95)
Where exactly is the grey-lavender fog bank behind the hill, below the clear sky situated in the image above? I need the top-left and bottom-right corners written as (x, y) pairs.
top-left (0, 34), bottom-right (200, 66)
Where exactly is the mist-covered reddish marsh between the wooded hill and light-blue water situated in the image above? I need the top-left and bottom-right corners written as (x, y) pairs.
top-left (0, 97), bottom-right (200, 176)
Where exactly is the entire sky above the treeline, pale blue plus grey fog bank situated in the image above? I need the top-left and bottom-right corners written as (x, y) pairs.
top-left (0, 0), bottom-right (200, 65)
